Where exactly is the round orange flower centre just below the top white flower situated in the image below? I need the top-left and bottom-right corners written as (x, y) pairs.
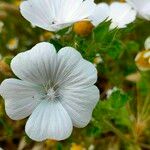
top-left (73, 21), bottom-right (94, 36)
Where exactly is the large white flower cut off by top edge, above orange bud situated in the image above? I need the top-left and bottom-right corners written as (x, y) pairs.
top-left (20, 0), bottom-right (96, 31)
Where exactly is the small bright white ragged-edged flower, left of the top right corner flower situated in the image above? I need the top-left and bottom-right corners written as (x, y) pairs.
top-left (109, 2), bottom-right (136, 29)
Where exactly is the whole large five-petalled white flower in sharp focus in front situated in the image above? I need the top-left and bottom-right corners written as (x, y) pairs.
top-left (0, 42), bottom-right (99, 141)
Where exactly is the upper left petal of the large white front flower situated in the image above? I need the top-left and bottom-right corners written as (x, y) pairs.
top-left (11, 42), bottom-right (57, 84)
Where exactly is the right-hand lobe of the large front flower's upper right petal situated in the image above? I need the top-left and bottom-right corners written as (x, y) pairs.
top-left (59, 59), bottom-right (97, 88)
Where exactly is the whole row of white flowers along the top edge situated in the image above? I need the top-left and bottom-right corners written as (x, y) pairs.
top-left (20, 0), bottom-right (150, 32)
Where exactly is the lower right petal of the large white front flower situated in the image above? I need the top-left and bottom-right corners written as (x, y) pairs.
top-left (61, 86), bottom-right (99, 128)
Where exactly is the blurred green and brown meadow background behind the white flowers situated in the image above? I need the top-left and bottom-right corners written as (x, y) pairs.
top-left (0, 0), bottom-right (150, 150)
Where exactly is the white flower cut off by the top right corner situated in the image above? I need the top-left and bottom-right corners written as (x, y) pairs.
top-left (126, 0), bottom-right (150, 20)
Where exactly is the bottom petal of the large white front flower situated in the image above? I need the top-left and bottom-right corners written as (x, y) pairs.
top-left (25, 100), bottom-right (73, 141)
